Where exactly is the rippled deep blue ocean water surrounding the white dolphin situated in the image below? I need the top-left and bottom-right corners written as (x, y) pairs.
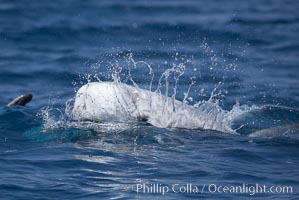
top-left (0, 0), bottom-right (299, 199)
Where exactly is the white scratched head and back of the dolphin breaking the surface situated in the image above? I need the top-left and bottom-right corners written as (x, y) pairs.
top-left (72, 82), bottom-right (232, 132)
